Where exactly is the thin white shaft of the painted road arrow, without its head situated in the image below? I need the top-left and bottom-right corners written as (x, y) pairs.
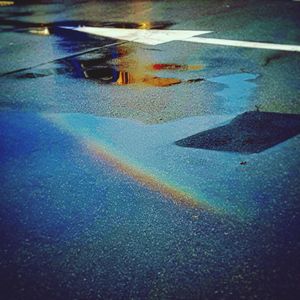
top-left (185, 37), bottom-right (300, 52)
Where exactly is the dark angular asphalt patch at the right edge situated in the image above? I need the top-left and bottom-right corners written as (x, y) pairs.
top-left (175, 111), bottom-right (300, 154)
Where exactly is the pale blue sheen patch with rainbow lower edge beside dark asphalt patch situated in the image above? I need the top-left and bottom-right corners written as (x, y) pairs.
top-left (44, 109), bottom-right (264, 221)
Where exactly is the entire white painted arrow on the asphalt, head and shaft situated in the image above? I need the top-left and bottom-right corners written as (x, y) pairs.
top-left (61, 26), bottom-right (300, 52)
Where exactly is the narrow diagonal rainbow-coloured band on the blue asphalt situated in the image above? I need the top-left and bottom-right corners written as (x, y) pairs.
top-left (44, 114), bottom-right (217, 213)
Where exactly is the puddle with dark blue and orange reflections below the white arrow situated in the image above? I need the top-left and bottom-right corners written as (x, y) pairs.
top-left (16, 55), bottom-right (204, 87)
